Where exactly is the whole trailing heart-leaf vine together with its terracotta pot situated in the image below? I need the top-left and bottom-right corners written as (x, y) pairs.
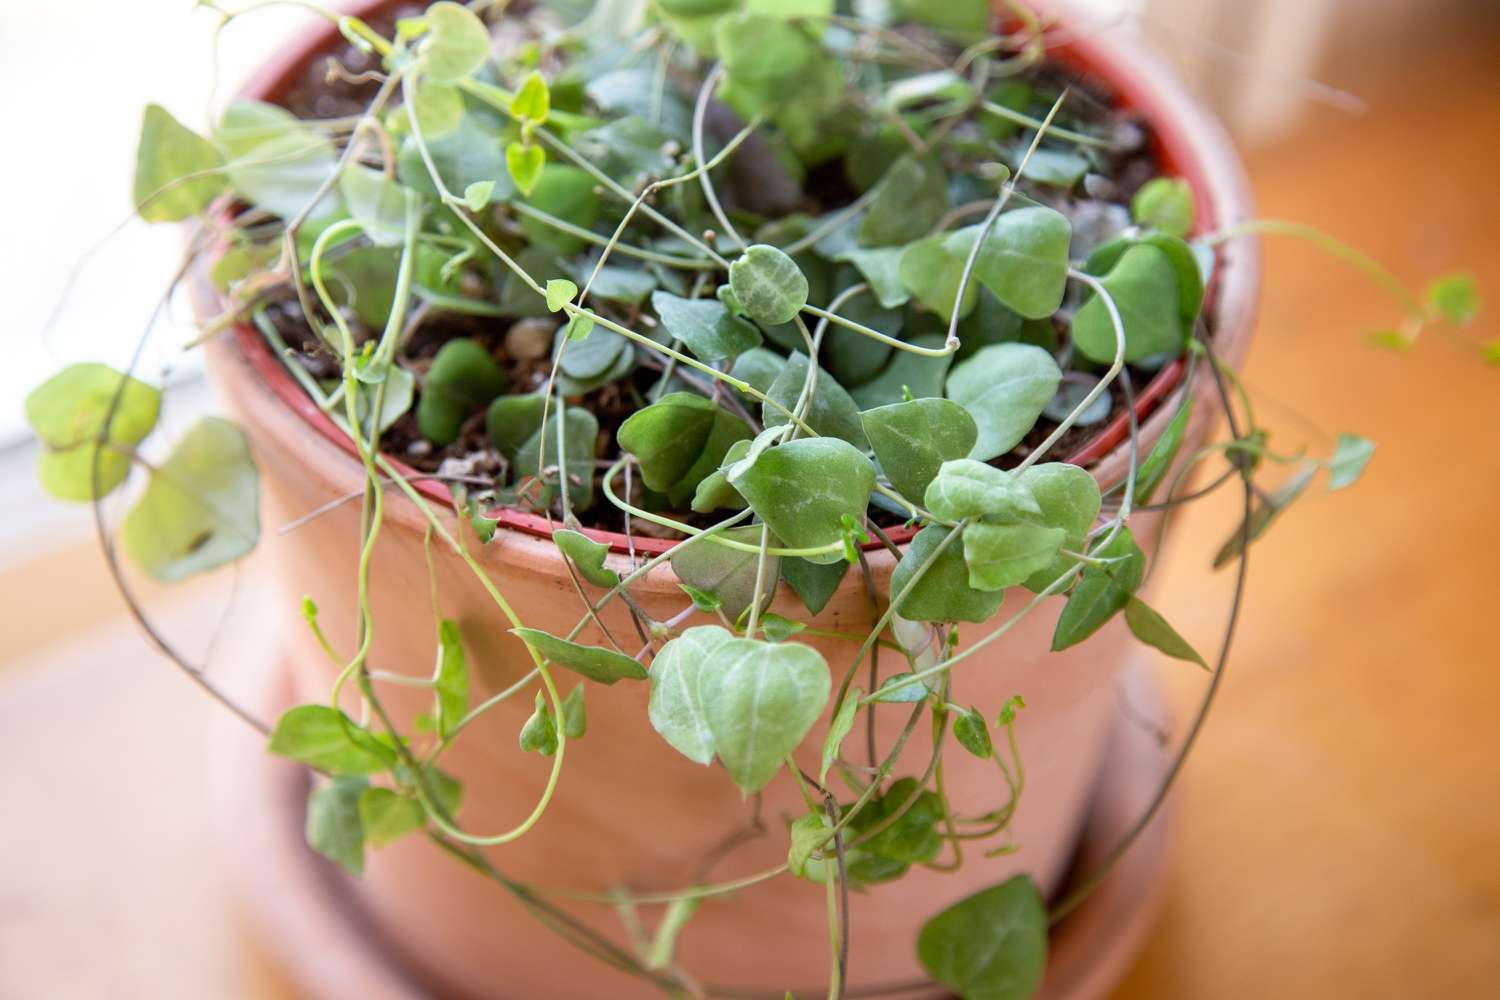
top-left (27, 0), bottom-right (1473, 999)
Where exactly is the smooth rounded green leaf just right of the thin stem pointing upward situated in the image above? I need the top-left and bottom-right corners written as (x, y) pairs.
top-left (954, 205), bottom-right (1074, 320)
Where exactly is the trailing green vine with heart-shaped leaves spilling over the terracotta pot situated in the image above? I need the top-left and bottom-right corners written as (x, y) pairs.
top-left (27, 0), bottom-right (1497, 997)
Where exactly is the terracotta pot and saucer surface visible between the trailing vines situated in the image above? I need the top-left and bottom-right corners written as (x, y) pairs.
top-left (199, 4), bottom-right (1259, 999)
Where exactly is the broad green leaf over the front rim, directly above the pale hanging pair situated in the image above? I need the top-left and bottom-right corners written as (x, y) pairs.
top-left (729, 438), bottom-right (875, 562)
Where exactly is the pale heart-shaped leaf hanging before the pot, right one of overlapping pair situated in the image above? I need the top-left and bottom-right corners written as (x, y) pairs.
top-left (698, 639), bottom-right (831, 796)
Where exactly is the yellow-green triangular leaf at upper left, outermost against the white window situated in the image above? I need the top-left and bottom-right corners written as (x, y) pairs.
top-left (134, 103), bottom-right (228, 222)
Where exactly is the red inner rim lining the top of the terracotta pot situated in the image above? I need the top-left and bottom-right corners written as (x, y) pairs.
top-left (233, 0), bottom-right (1220, 555)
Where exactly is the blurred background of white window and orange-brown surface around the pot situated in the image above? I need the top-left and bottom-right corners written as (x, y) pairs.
top-left (0, 0), bottom-right (1500, 1000)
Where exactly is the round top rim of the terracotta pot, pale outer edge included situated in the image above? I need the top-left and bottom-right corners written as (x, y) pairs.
top-left (215, 0), bottom-right (1260, 556)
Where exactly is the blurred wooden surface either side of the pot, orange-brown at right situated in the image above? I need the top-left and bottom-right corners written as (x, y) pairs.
top-left (0, 29), bottom-right (1500, 1000)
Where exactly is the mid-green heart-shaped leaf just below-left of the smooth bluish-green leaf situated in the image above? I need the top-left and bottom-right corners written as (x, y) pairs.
top-left (860, 399), bottom-right (989, 503)
